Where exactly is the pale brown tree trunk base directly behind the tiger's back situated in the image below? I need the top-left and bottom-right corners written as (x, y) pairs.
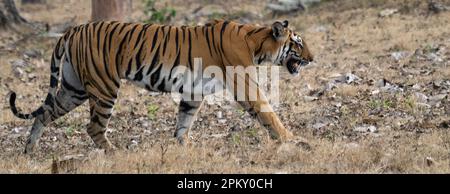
top-left (92, 0), bottom-right (132, 21)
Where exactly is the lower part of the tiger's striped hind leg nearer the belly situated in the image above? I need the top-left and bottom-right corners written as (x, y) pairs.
top-left (87, 96), bottom-right (114, 152)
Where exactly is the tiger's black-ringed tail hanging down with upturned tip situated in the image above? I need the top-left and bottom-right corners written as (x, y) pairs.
top-left (9, 37), bottom-right (66, 119)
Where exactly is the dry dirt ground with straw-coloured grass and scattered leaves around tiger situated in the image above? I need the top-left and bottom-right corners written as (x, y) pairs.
top-left (0, 0), bottom-right (450, 173)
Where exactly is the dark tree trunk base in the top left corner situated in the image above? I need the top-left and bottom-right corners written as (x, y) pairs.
top-left (0, 0), bottom-right (27, 30)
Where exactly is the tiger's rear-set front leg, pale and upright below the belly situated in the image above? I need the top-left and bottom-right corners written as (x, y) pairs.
top-left (175, 100), bottom-right (203, 145)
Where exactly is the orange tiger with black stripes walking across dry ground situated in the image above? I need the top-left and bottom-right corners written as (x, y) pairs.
top-left (9, 20), bottom-right (313, 154)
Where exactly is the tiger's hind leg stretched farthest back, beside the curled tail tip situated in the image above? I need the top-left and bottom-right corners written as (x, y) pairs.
top-left (24, 63), bottom-right (88, 154)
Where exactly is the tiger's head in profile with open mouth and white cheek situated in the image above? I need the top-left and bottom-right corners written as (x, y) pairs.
top-left (253, 21), bottom-right (314, 76)
